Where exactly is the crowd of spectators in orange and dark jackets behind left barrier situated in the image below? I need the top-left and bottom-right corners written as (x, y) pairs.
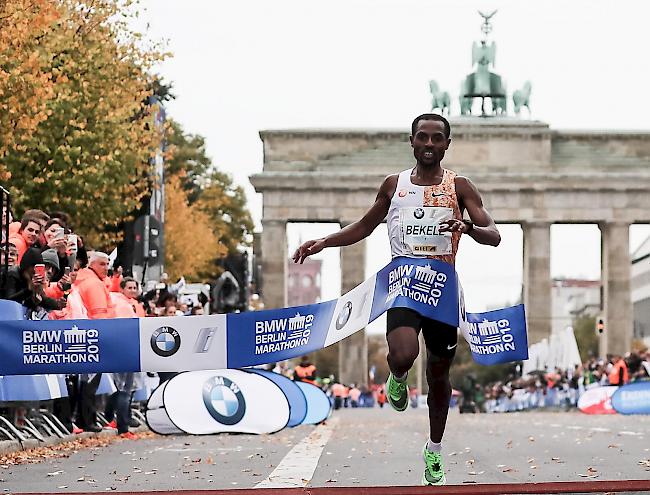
top-left (0, 207), bottom-right (207, 438)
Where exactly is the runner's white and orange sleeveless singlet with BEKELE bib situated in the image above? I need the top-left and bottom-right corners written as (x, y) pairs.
top-left (386, 169), bottom-right (463, 265)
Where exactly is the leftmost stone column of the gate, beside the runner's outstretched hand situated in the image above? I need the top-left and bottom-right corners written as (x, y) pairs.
top-left (261, 220), bottom-right (289, 309)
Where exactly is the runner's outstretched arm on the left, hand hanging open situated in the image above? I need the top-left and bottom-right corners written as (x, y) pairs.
top-left (293, 175), bottom-right (397, 263)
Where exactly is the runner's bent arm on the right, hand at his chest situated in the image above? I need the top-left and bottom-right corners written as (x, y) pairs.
top-left (448, 177), bottom-right (501, 246)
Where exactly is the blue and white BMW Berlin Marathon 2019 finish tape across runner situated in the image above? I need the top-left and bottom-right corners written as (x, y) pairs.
top-left (0, 257), bottom-right (528, 375)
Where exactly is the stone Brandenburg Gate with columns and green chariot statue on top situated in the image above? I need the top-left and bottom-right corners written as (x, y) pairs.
top-left (251, 12), bottom-right (650, 383)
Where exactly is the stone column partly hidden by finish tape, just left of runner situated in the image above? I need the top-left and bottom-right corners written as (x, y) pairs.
top-left (337, 236), bottom-right (368, 385)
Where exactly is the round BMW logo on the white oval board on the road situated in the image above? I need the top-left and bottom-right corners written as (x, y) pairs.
top-left (203, 375), bottom-right (246, 425)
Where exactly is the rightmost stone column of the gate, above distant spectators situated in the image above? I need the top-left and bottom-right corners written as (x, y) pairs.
top-left (599, 222), bottom-right (633, 357)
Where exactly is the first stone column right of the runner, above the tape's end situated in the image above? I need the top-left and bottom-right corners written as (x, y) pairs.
top-left (522, 222), bottom-right (552, 346)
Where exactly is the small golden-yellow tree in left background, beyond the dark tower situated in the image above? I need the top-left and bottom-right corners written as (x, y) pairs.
top-left (165, 175), bottom-right (228, 281)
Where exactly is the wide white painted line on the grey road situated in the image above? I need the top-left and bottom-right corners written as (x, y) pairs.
top-left (254, 418), bottom-right (338, 488)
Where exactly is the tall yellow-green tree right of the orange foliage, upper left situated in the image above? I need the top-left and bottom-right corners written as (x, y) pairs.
top-left (0, 0), bottom-right (163, 248)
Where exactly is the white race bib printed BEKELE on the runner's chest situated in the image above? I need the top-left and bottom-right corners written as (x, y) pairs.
top-left (399, 206), bottom-right (453, 256)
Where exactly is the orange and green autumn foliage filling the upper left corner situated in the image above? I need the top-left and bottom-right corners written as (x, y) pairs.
top-left (0, 0), bottom-right (162, 246)
